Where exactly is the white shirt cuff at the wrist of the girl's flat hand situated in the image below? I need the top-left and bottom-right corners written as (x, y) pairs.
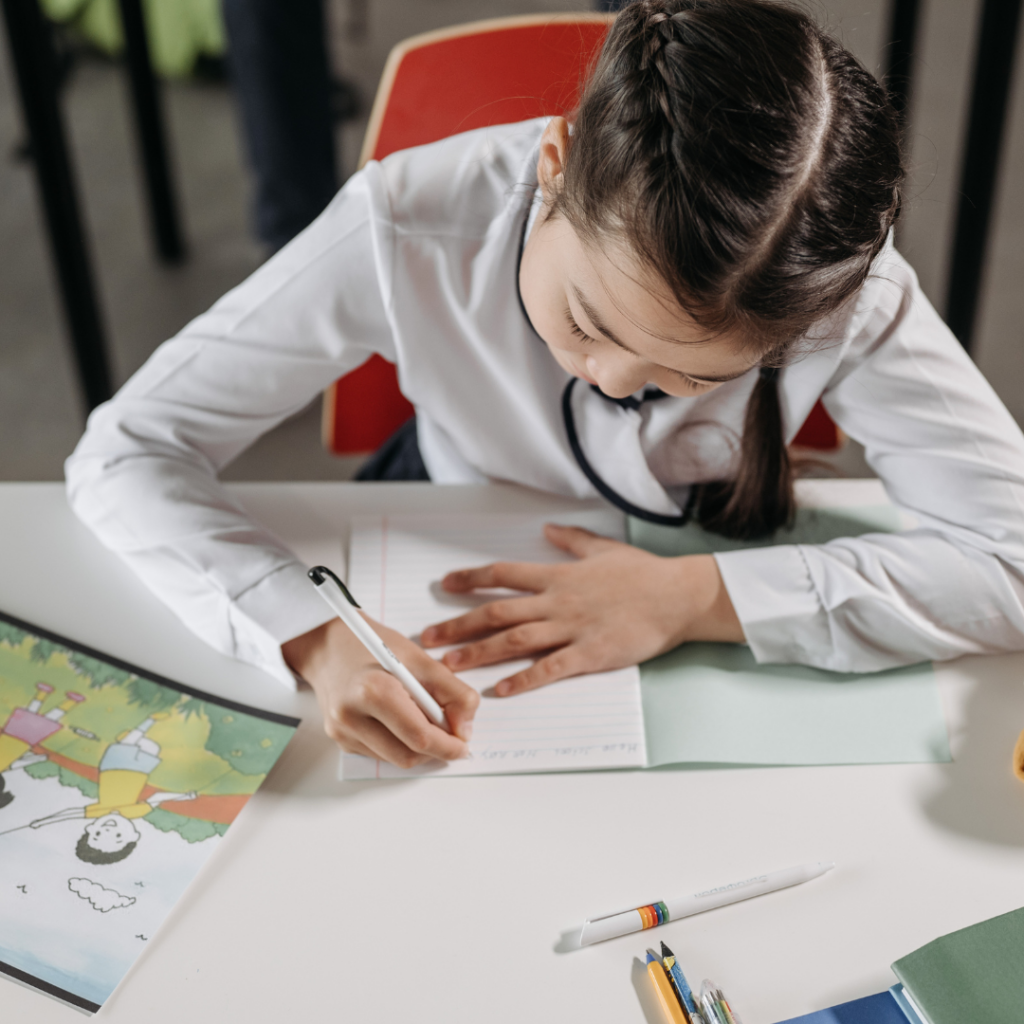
top-left (715, 545), bottom-right (833, 668)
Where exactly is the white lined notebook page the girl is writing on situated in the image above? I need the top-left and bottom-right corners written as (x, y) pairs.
top-left (341, 512), bottom-right (646, 779)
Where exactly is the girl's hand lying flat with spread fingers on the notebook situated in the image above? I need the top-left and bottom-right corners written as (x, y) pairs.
top-left (420, 523), bottom-right (743, 696)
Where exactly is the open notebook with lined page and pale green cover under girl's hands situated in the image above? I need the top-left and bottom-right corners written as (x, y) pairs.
top-left (341, 506), bottom-right (949, 779)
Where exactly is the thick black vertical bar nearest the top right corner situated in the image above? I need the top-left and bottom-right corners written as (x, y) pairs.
top-left (946, 0), bottom-right (1021, 351)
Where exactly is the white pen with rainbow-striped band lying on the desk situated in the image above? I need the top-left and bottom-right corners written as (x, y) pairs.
top-left (580, 860), bottom-right (836, 946)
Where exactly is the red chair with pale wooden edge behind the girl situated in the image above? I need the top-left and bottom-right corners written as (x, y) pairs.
top-left (323, 14), bottom-right (839, 455)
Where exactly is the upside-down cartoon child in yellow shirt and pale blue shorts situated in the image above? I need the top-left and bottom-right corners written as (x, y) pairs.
top-left (24, 712), bottom-right (196, 864)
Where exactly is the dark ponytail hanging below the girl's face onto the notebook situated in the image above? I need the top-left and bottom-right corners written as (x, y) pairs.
top-left (694, 367), bottom-right (796, 541)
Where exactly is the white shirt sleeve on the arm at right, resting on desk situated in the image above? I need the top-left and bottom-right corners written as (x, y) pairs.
top-left (716, 253), bottom-right (1024, 672)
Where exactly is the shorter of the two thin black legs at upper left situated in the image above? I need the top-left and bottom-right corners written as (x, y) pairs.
top-left (120, 0), bottom-right (185, 263)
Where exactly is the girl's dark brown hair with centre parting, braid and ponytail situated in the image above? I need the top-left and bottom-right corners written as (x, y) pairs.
top-left (554, 0), bottom-right (903, 538)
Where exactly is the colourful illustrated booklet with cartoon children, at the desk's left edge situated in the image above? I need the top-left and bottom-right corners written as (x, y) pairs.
top-left (0, 616), bottom-right (298, 1011)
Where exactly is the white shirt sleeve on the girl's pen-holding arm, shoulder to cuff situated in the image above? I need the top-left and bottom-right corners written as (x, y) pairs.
top-left (66, 172), bottom-right (394, 686)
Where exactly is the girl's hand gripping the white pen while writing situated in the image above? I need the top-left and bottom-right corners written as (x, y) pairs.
top-left (282, 618), bottom-right (480, 768)
